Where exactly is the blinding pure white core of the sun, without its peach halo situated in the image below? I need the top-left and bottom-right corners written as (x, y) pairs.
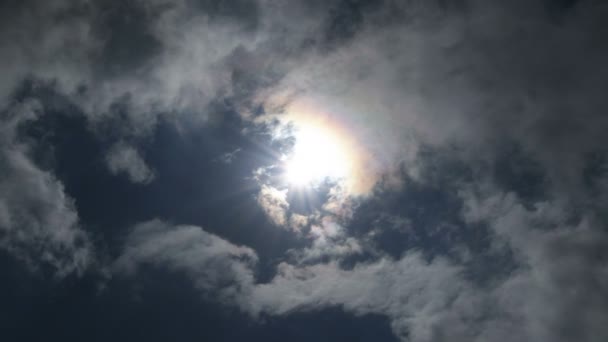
top-left (285, 126), bottom-right (350, 186)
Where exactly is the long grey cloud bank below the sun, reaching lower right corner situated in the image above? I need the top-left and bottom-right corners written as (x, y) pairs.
top-left (115, 190), bottom-right (608, 341)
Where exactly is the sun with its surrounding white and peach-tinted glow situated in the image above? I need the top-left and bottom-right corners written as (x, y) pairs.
top-left (273, 99), bottom-right (381, 197)
